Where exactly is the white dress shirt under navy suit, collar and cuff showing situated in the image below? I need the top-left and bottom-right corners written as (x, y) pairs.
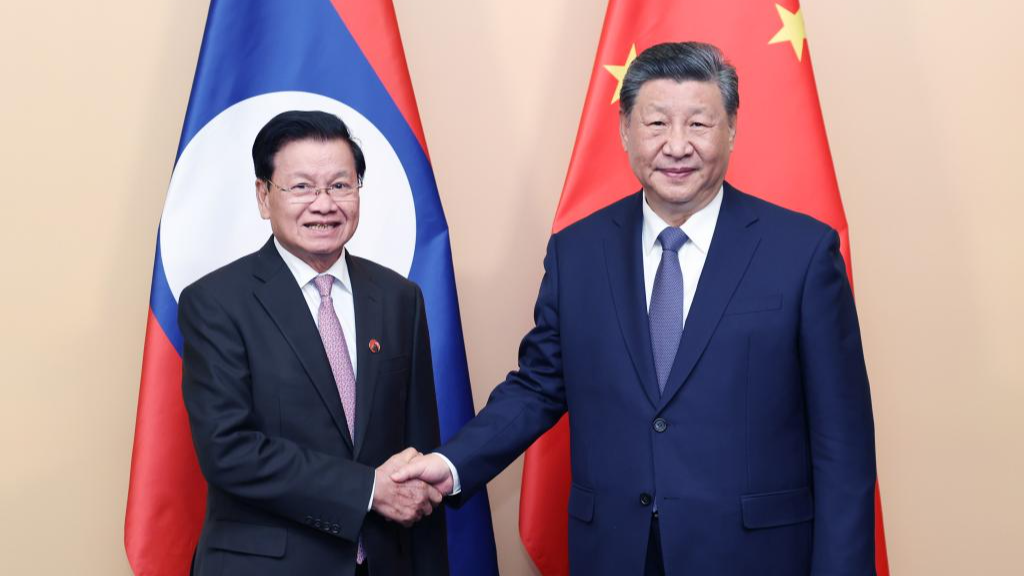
top-left (444, 188), bottom-right (723, 494)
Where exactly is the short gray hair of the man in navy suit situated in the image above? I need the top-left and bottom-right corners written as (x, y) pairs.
top-left (618, 42), bottom-right (739, 118)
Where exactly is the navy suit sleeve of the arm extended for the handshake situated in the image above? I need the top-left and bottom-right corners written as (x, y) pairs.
top-left (439, 235), bottom-right (566, 505)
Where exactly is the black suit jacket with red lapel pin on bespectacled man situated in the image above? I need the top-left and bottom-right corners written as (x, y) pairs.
top-left (179, 239), bottom-right (447, 576)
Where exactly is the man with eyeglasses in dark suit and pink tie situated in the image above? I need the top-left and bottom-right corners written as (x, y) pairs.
top-left (179, 112), bottom-right (447, 576)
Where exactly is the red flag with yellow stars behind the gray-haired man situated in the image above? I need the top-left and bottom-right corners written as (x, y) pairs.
top-left (519, 0), bottom-right (889, 576)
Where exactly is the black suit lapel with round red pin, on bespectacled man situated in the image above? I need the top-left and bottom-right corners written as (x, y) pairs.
top-left (346, 251), bottom-right (388, 457)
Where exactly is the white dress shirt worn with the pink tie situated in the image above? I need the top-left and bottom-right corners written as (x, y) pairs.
top-left (273, 238), bottom-right (377, 510)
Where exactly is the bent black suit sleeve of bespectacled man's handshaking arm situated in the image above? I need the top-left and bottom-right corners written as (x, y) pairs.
top-left (178, 285), bottom-right (374, 541)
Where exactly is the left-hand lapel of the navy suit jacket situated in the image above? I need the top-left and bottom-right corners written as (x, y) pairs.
top-left (604, 194), bottom-right (659, 406)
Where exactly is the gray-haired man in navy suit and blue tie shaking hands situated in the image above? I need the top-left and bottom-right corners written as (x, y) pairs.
top-left (392, 42), bottom-right (876, 576)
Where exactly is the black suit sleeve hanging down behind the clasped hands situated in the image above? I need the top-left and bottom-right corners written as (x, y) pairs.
top-left (406, 288), bottom-right (449, 576)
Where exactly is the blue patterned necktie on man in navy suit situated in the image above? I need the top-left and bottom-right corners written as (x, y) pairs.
top-left (647, 227), bottom-right (687, 392)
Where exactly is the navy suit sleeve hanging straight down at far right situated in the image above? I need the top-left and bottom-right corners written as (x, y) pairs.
top-left (800, 230), bottom-right (876, 576)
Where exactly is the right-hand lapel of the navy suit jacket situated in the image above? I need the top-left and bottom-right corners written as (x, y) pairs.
top-left (657, 183), bottom-right (761, 411)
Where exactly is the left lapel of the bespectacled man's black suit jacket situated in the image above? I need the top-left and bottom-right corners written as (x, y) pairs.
top-left (253, 238), bottom-right (357, 450)
